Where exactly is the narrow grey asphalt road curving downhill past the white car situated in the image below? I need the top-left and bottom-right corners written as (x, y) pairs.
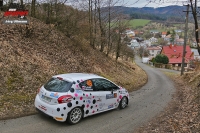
top-left (0, 58), bottom-right (175, 133)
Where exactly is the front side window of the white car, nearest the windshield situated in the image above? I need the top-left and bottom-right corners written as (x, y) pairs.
top-left (92, 79), bottom-right (119, 91)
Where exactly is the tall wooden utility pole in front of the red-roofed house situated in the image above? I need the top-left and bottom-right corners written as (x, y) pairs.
top-left (181, 4), bottom-right (190, 76)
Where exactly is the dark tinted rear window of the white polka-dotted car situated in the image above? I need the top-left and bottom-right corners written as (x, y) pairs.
top-left (44, 78), bottom-right (72, 92)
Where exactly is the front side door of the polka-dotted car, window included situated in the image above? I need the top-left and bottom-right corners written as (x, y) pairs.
top-left (92, 79), bottom-right (119, 111)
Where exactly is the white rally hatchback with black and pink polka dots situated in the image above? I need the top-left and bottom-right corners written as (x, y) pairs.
top-left (35, 73), bottom-right (129, 124)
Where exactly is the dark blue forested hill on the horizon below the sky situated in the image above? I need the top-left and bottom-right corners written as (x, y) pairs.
top-left (105, 6), bottom-right (186, 21)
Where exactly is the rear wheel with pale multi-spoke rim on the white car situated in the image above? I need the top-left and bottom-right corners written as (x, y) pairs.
top-left (67, 107), bottom-right (83, 125)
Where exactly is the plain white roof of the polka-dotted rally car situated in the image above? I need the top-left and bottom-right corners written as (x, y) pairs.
top-left (53, 73), bottom-right (103, 82)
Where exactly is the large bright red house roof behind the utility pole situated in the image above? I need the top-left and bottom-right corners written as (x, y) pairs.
top-left (161, 44), bottom-right (194, 64)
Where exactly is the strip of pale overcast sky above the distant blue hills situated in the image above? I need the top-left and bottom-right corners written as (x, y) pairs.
top-left (123, 0), bottom-right (187, 8)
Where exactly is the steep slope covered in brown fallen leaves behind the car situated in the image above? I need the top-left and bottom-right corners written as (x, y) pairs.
top-left (0, 18), bottom-right (147, 119)
